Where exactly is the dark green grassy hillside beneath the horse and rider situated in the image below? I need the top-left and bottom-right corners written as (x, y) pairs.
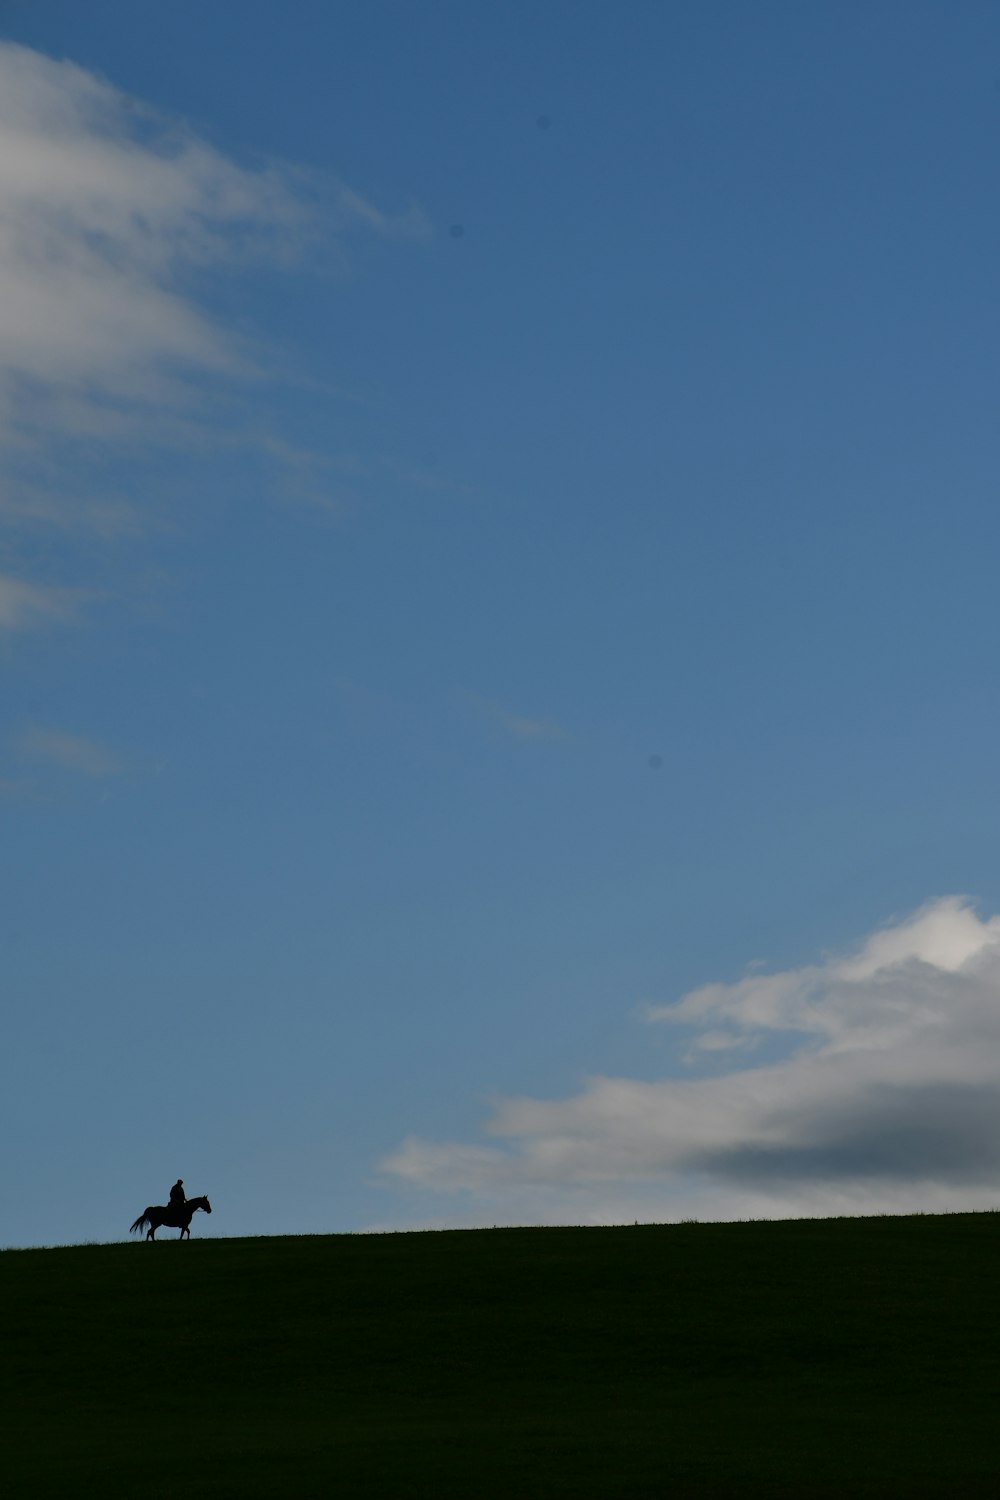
top-left (0, 1214), bottom-right (1000, 1500)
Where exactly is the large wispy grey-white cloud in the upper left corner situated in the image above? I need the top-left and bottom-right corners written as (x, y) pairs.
top-left (0, 44), bottom-right (426, 435)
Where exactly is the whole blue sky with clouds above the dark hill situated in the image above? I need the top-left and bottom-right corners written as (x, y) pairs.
top-left (0, 0), bottom-right (1000, 1247)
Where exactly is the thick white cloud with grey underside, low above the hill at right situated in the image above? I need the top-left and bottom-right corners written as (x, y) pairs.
top-left (382, 897), bottom-right (1000, 1221)
